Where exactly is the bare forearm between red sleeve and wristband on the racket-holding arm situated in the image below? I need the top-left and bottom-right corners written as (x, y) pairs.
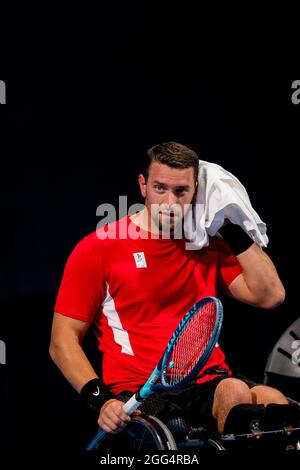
top-left (50, 339), bottom-right (97, 392)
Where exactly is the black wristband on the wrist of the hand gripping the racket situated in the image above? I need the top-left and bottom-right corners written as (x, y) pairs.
top-left (80, 378), bottom-right (114, 412)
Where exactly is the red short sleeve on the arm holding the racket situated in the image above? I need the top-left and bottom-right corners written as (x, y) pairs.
top-left (55, 234), bottom-right (105, 322)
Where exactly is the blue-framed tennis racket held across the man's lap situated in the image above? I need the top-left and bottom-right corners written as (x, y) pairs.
top-left (86, 297), bottom-right (223, 450)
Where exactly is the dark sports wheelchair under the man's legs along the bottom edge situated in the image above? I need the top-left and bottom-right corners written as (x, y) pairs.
top-left (90, 400), bottom-right (300, 455)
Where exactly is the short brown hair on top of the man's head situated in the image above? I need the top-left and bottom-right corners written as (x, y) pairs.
top-left (144, 142), bottom-right (199, 183)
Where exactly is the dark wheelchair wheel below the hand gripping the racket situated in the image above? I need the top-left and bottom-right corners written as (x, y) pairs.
top-left (97, 416), bottom-right (177, 454)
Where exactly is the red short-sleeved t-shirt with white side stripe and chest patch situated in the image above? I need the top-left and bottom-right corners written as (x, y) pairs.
top-left (55, 216), bottom-right (242, 394)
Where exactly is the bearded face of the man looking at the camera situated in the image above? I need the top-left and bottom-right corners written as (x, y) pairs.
top-left (139, 162), bottom-right (196, 234)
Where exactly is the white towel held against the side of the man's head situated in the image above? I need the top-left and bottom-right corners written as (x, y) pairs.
top-left (184, 160), bottom-right (269, 250)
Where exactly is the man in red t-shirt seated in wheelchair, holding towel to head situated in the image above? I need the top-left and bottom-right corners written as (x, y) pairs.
top-left (50, 142), bottom-right (287, 438)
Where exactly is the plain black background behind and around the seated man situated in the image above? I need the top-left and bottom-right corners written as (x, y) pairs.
top-left (0, 2), bottom-right (300, 456)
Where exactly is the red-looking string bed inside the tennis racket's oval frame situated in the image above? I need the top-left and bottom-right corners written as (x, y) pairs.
top-left (167, 302), bottom-right (216, 385)
